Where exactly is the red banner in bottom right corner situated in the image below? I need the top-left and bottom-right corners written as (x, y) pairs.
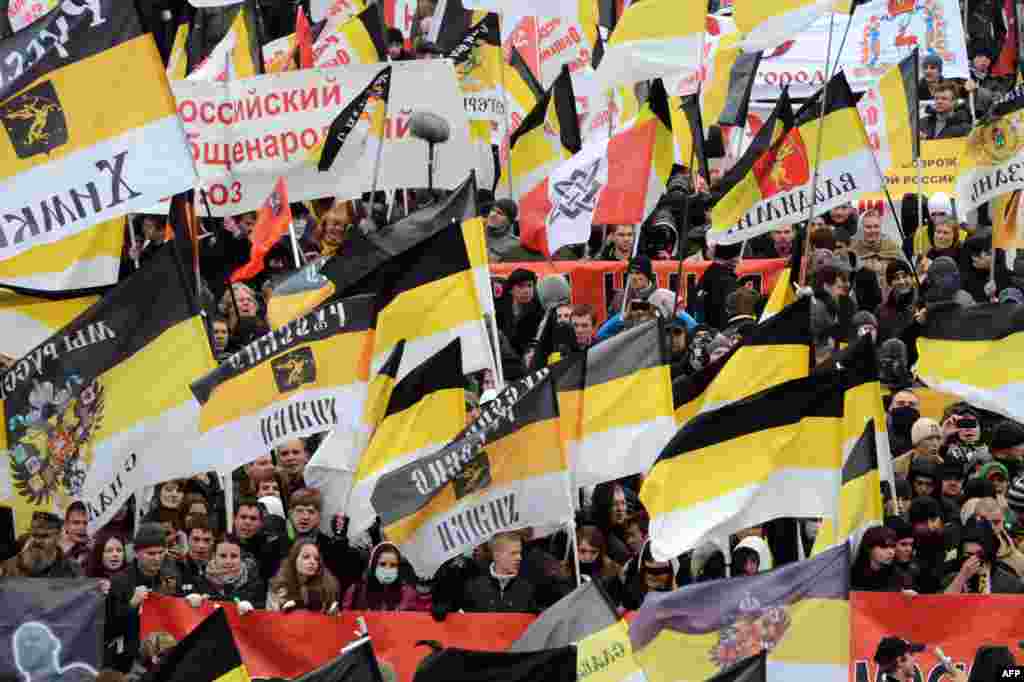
top-left (850, 592), bottom-right (1024, 682)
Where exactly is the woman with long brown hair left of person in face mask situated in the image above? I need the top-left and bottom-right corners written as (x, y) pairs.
top-left (266, 540), bottom-right (341, 613)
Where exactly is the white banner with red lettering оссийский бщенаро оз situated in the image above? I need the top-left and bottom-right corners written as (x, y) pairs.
top-left (173, 60), bottom-right (490, 217)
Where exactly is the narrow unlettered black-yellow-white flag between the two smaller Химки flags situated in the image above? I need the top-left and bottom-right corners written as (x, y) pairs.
top-left (337, 339), bottom-right (466, 536)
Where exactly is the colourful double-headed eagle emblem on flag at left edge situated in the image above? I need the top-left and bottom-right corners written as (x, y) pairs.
top-left (6, 375), bottom-right (105, 508)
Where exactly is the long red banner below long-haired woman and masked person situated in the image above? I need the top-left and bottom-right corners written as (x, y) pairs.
top-left (142, 595), bottom-right (534, 682)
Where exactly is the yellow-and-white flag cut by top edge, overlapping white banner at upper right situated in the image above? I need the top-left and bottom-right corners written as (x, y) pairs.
top-left (732, 0), bottom-right (853, 51)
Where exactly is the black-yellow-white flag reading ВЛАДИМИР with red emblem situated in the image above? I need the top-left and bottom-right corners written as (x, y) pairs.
top-left (708, 72), bottom-right (885, 244)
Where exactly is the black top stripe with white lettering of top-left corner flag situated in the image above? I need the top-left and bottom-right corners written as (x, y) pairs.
top-left (0, 0), bottom-right (142, 101)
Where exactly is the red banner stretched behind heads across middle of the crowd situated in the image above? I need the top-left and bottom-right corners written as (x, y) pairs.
top-left (490, 258), bottom-right (787, 325)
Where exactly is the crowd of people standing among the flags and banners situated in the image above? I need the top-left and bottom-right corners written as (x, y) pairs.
top-left (0, 0), bottom-right (1024, 679)
